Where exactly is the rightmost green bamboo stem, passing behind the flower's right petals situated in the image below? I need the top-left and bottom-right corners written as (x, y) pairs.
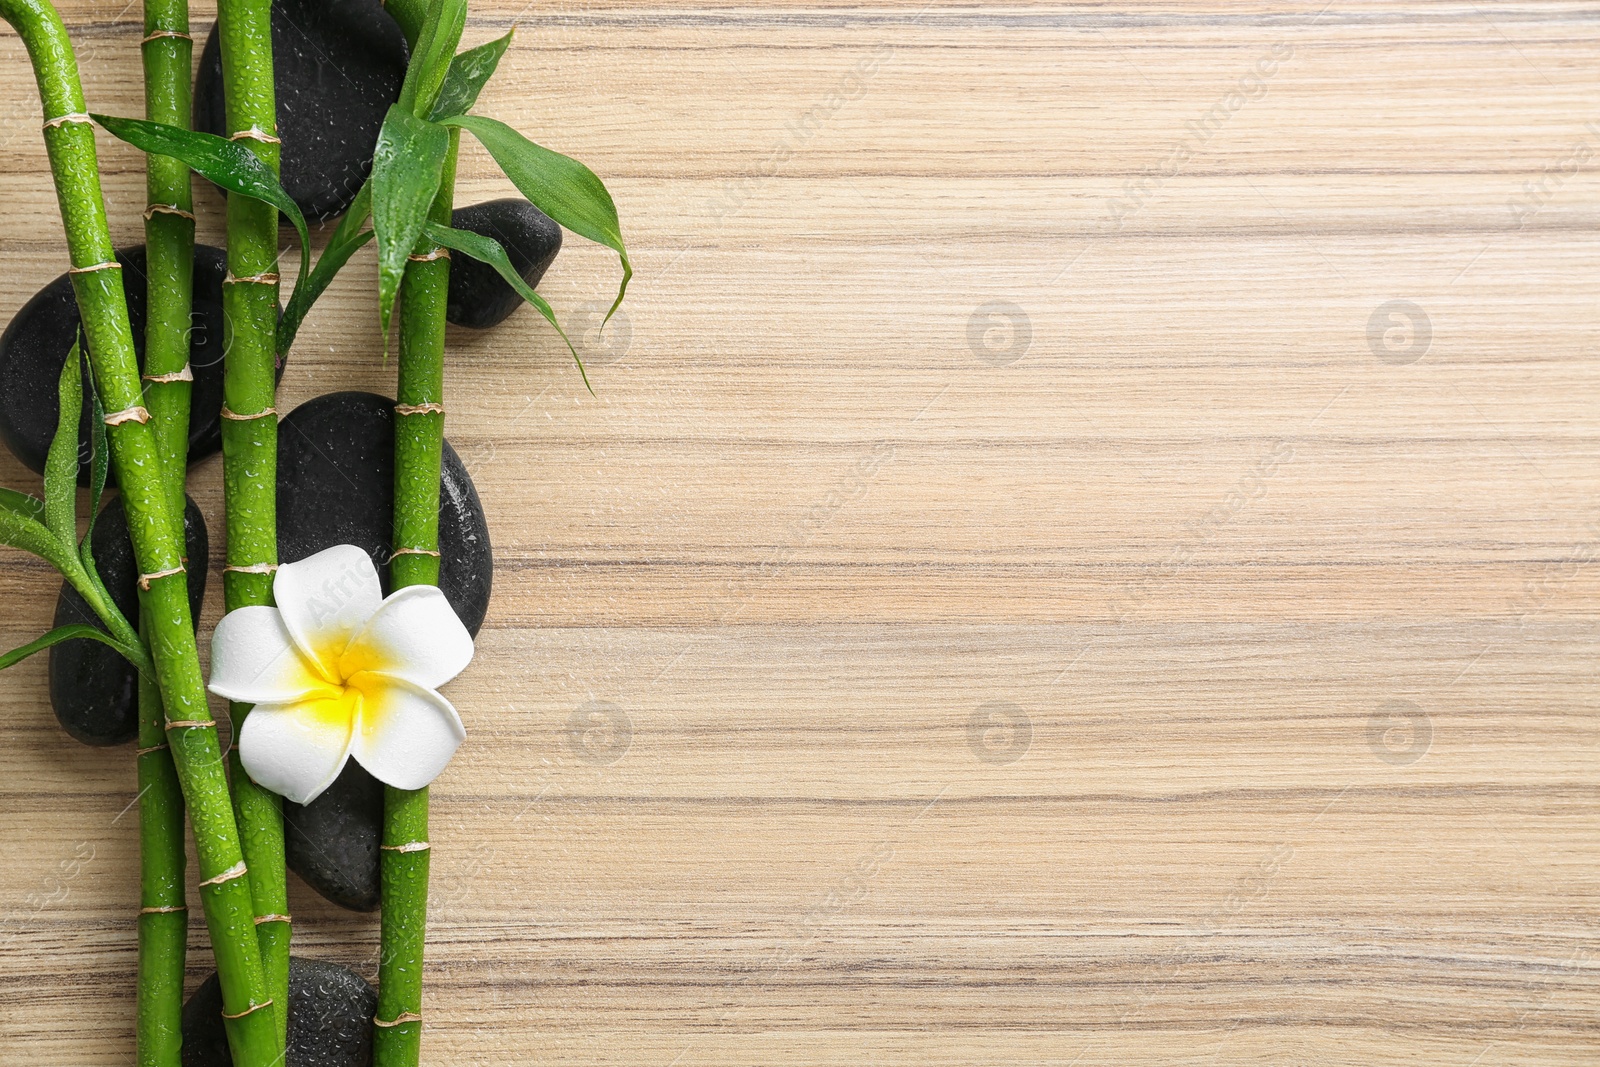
top-left (373, 130), bottom-right (461, 1067)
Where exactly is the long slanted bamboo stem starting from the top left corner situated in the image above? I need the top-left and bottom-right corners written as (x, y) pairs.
top-left (0, 0), bottom-right (282, 1067)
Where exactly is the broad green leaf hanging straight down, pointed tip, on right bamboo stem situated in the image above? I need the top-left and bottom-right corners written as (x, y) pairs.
top-left (373, 104), bottom-right (450, 352)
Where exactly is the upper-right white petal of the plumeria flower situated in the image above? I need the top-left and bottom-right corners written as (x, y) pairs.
top-left (339, 585), bottom-right (472, 689)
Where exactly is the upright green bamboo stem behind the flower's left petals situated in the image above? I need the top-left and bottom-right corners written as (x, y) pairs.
top-left (216, 0), bottom-right (291, 1040)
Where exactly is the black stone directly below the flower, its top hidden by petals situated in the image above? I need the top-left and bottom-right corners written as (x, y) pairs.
top-left (283, 760), bottom-right (384, 912)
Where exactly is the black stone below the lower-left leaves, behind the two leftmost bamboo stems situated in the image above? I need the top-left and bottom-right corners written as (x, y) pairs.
top-left (50, 496), bottom-right (211, 745)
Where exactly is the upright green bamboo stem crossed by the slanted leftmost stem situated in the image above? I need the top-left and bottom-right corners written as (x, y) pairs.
top-left (136, 0), bottom-right (193, 1067)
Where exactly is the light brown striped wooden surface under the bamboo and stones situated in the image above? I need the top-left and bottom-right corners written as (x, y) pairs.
top-left (0, 0), bottom-right (1600, 1067)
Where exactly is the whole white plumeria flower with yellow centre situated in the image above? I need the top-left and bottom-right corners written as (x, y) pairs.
top-left (208, 544), bottom-right (472, 805)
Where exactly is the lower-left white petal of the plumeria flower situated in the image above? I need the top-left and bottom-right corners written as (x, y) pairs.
top-left (238, 693), bottom-right (357, 805)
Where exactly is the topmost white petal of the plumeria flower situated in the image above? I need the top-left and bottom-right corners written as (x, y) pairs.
top-left (272, 544), bottom-right (384, 678)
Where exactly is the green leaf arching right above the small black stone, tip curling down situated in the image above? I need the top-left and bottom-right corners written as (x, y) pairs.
top-left (440, 115), bottom-right (634, 325)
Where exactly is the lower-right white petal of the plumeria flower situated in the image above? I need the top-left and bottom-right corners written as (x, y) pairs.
top-left (352, 673), bottom-right (467, 789)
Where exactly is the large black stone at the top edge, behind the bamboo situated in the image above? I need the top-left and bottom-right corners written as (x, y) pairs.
top-left (195, 0), bottom-right (406, 221)
